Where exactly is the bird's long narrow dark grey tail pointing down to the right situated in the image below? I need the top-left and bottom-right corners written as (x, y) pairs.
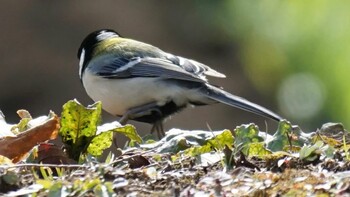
top-left (201, 84), bottom-right (283, 121)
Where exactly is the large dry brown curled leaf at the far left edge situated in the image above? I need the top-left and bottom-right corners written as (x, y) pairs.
top-left (0, 115), bottom-right (59, 163)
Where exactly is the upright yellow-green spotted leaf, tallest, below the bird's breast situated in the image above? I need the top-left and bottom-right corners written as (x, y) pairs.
top-left (60, 100), bottom-right (102, 160)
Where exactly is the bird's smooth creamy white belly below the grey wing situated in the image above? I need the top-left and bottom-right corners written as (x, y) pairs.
top-left (83, 73), bottom-right (197, 116)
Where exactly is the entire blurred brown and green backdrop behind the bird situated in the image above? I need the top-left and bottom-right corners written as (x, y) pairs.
top-left (0, 0), bottom-right (350, 134)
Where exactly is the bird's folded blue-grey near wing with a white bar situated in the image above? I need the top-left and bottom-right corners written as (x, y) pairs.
top-left (89, 57), bottom-right (207, 83)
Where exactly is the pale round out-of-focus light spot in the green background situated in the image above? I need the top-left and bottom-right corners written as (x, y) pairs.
top-left (278, 73), bottom-right (326, 120)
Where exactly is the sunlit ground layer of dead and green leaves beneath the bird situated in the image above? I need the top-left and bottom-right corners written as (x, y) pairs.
top-left (0, 100), bottom-right (350, 196)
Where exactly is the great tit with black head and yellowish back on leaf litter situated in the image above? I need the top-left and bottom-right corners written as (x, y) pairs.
top-left (78, 29), bottom-right (282, 135)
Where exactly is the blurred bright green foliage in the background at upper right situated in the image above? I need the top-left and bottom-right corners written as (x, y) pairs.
top-left (197, 0), bottom-right (350, 129)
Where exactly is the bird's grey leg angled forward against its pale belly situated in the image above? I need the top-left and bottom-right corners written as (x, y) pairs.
top-left (119, 102), bottom-right (158, 125)
